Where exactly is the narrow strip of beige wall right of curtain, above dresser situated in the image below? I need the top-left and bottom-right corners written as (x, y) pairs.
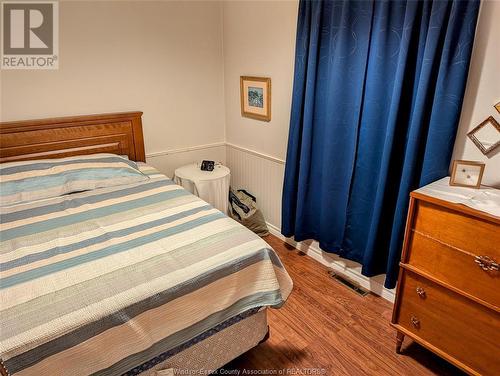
top-left (452, 0), bottom-right (500, 188)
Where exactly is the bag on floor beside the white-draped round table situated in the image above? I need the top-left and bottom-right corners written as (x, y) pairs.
top-left (229, 188), bottom-right (269, 236)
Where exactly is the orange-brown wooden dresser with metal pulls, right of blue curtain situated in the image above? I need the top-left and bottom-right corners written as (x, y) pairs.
top-left (392, 181), bottom-right (500, 375)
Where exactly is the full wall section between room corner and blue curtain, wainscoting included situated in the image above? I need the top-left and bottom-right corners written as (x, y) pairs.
top-left (223, 0), bottom-right (298, 228)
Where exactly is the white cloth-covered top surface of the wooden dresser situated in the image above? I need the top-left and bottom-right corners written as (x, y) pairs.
top-left (412, 176), bottom-right (500, 219)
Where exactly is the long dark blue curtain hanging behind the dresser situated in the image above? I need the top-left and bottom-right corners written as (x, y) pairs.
top-left (282, 0), bottom-right (479, 288)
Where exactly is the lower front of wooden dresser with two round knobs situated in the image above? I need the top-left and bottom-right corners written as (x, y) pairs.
top-left (394, 271), bottom-right (500, 375)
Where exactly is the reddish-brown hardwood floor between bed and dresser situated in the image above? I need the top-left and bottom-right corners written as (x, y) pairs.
top-left (220, 235), bottom-right (463, 376)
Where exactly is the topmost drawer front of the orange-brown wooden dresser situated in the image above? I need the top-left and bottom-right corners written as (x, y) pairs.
top-left (413, 200), bottom-right (500, 261)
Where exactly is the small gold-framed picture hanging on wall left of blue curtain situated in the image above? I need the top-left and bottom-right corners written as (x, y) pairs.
top-left (240, 76), bottom-right (271, 121)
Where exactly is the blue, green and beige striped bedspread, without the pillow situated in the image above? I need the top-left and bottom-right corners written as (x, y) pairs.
top-left (0, 165), bottom-right (292, 376)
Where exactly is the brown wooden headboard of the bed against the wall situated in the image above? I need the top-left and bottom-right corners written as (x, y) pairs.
top-left (0, 112), bottom-right (146, 162)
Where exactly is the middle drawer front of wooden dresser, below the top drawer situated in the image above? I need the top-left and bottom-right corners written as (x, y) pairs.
top-left (406, 230), bottom-right (500, 309)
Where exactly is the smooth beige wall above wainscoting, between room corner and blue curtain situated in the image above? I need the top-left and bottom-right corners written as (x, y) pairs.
top-left (224, 1), bottom-right (298, 159)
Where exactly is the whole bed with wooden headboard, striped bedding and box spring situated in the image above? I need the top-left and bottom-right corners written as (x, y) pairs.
top-left (0, 112), bottom-right (292, 376)
